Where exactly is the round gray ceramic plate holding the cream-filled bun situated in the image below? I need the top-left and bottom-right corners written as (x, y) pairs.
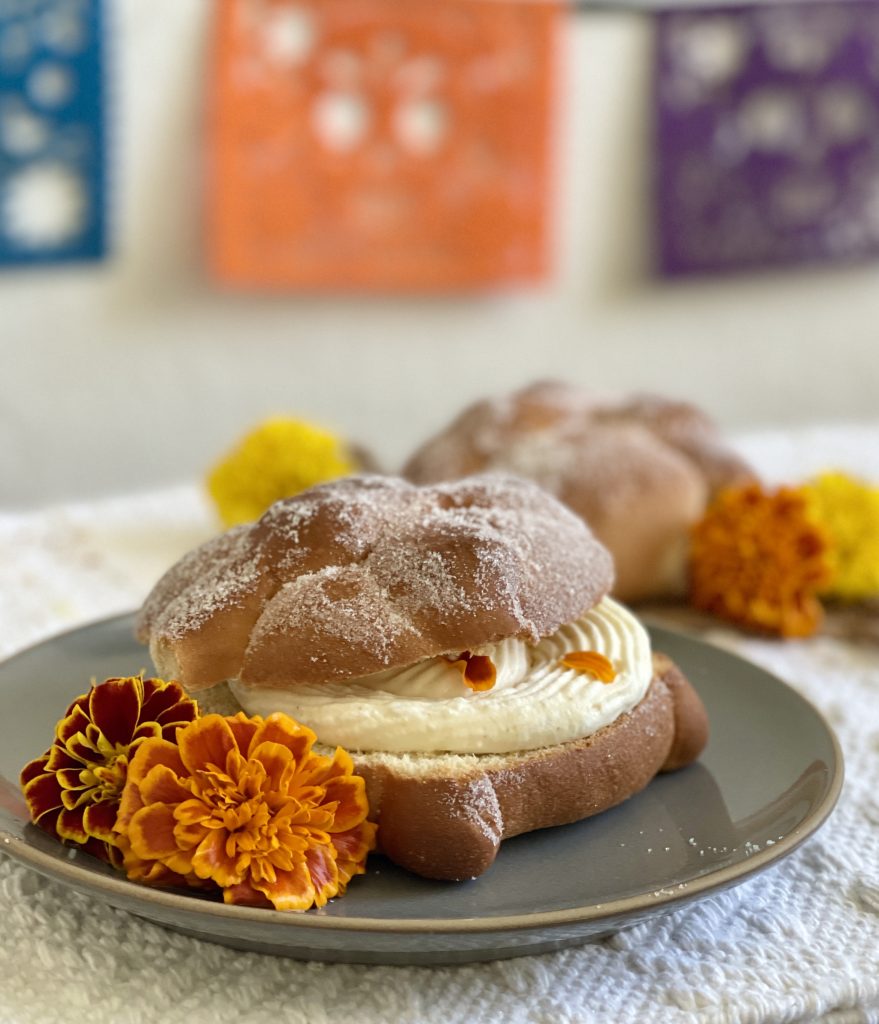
top-left (0, 616), bottom-right (842, 964)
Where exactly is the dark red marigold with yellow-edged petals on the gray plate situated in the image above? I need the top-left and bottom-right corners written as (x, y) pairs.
top-left (20, 676), bottom-right (198, 866)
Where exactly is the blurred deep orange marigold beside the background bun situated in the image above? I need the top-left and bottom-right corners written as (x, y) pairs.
top-left (690, 483), bottom-right (832, 637)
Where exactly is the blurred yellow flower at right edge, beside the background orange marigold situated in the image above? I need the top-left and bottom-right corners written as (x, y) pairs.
top-left (803, 472), bottom-right (879, 601)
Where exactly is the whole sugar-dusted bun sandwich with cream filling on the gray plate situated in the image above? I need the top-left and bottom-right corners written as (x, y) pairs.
top-left (138, 475), bottom-right (707, 879)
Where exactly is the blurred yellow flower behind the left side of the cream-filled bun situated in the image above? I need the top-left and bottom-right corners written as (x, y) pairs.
top-left (207, 417), bottom-right (359, 526)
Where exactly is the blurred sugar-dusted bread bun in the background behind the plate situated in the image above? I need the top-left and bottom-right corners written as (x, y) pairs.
top-left (403, 382), bottom-right (754, 601)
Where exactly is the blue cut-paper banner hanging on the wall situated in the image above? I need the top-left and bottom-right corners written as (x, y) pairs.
top-left (0, 0), bottom-right (104, 265)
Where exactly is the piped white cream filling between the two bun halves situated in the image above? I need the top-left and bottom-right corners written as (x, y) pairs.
top-left (231, 598), bottom-right (653, 754)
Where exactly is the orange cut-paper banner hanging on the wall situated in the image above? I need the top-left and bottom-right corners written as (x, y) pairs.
top-left (208, 0), bottom-right (558, 291)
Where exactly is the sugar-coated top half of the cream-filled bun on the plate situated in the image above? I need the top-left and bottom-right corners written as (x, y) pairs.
top-left (137, 474), bottom-right (613, 690)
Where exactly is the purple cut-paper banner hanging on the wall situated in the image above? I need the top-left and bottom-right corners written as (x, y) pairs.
top-left (656, 0), bottom-right (879, 275)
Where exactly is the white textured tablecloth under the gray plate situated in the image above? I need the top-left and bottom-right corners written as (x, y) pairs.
top-left (0, 425), bottom-right (879, 1024)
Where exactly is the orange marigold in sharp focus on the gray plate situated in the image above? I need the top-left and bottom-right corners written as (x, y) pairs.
top-left (116, 713), bottom-right (376, 910)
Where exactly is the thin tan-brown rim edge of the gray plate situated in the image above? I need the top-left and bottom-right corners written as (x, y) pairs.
top-left (0, 611), bottom-right (845, 935)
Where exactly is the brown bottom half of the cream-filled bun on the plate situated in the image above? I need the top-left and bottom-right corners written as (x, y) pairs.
top-left (353, 654), bottom-right (708, 881)
